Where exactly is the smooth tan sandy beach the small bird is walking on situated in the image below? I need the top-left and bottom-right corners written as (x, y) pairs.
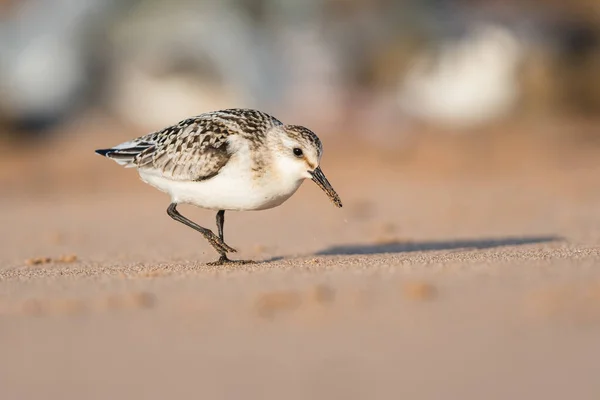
top-left (0, 127), bottom-right (600, 399)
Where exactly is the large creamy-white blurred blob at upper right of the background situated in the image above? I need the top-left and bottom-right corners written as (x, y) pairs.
top-left (399, 24), bottom-right (523, 128)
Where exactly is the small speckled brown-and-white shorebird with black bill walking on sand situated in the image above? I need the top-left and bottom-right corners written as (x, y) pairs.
top-left (96, 109), bottom-right (342, 265)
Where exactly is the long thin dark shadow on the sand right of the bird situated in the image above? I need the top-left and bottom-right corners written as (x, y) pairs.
top-left (314, 235), bottom-right (564, 256)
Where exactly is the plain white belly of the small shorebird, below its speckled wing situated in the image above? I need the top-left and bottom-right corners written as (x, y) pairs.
top-left (139, 165), bottom-right (303, 211)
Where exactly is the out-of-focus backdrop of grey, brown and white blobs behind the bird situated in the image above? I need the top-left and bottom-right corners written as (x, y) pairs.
top-left (0, 0), bottom-right (600, 195)
